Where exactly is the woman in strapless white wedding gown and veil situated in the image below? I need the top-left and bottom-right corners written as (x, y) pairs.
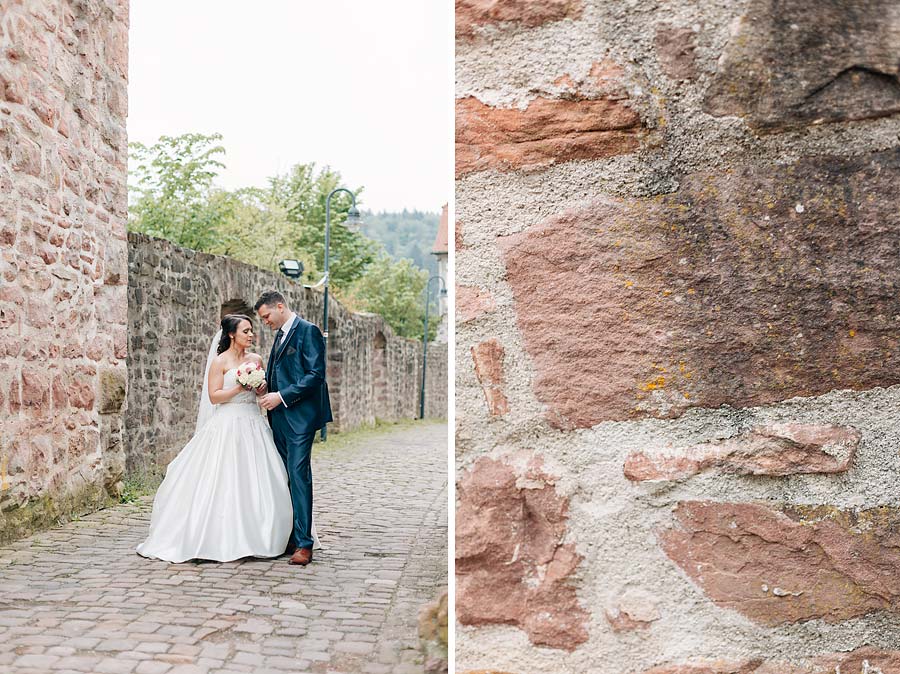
top-left (135, 314), bottom-right (318, 562)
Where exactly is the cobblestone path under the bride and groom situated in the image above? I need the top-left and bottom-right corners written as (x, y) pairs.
top-left (0, 423), bottom-right (447, 674)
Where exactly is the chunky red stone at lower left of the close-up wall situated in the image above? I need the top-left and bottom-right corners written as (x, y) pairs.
top-left (456, 458), bottom-right (589, 650)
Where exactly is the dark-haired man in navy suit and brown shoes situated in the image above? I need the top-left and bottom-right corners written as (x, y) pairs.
top-left (253, 291), bottom-right (331, 566)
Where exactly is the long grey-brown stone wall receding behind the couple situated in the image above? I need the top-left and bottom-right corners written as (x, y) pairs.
top-left (125, 233), bottom-right (447, 471)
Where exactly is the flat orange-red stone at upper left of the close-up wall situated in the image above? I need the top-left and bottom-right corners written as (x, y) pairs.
top-left (456, 96), bottom-right (642, 177)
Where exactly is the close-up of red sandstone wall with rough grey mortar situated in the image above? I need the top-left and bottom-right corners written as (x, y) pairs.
top-left (456, 0), bottom-right (900, 674)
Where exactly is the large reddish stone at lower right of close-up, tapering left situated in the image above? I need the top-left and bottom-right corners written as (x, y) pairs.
top-left (660, 501), bottom-right (900, 626)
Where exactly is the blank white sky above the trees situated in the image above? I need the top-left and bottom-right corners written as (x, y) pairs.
top-left (128, 0), bottom-right (453, 211)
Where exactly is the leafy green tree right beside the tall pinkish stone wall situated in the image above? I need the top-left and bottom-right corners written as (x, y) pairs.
top-left (128, 133), bottom-right (234, 251)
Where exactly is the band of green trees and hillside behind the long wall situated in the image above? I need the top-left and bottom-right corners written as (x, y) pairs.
top-left (128, 133), bottom-right (439, 338)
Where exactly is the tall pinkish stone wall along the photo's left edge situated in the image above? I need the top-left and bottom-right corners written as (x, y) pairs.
top-left (0, 0), bottom-right (128, 542)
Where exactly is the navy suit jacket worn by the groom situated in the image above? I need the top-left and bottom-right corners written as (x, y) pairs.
top-left (266, 316), bottom-right (332, 433)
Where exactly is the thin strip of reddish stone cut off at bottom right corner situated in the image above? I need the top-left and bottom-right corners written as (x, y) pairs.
top-left (644, 646), bottom-right (900, 674)
